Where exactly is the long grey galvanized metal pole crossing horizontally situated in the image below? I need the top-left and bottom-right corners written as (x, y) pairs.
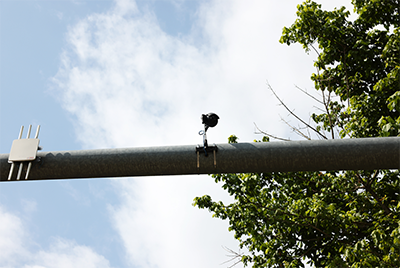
top-left (0, 137), bottom-right (400, 181)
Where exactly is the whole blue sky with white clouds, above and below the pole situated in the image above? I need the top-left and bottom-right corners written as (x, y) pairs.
top-left (0, 0), bottom-right (350, 268)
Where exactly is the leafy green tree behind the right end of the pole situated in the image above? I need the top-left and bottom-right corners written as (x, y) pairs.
top-left (194, 0), bottom-right (400, 267)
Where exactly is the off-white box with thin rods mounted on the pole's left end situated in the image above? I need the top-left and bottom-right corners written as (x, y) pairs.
top-left (8, 125), bottom-right (41, 180)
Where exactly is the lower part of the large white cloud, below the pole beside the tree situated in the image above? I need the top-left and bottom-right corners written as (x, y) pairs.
top-left (111, 176), bottom-right (240, 267)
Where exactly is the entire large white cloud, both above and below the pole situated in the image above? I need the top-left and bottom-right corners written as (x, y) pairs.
top-left (54, 0), bottom-right (354, 267)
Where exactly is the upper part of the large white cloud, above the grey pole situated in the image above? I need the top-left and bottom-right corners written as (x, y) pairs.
top-left (57, 1), bottom-right (310, 148)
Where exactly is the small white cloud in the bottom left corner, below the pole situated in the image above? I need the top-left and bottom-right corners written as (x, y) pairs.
top-left (0, 205), bottom-right (110, 268)
